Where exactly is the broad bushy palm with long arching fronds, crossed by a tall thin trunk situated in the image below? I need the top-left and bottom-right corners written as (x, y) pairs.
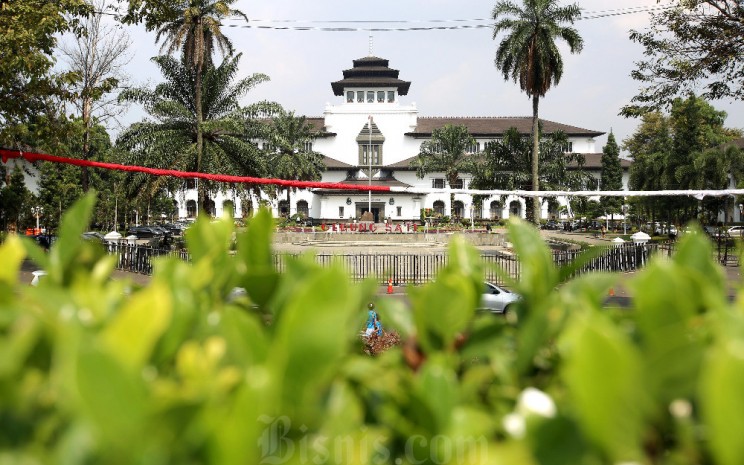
top-left (117, 54), bottom-right (277, 211)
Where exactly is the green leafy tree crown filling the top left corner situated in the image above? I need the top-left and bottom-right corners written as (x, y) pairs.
top-left (0, 0), bottom-right (90, 145)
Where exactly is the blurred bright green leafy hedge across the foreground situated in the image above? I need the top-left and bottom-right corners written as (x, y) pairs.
top-left (0, 191), bottom-right (744, 465)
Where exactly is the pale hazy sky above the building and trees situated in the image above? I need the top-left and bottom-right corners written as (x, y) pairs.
top-left (110, 0), bottom-right (744, 156)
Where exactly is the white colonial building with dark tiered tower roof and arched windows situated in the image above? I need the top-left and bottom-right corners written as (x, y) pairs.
top-left (176, 56), bottom-right (629, 222)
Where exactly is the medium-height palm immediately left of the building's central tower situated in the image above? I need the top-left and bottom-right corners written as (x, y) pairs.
top-left (266, 111), bottom-right (325, 216)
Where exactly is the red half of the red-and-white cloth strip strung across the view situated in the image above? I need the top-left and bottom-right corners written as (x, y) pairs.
top-left (0, 148), bottom-right (390, 192)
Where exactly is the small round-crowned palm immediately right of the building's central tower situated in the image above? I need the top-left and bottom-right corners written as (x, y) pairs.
top-left (411, 124), bottom-right (475, 217)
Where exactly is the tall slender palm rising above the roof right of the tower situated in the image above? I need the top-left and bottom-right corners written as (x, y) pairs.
top-left (492, 0), bottom-right (584, 222)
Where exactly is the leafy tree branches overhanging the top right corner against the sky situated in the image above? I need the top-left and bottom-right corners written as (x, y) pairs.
top-left (621, 0), bottom-right (744, 116)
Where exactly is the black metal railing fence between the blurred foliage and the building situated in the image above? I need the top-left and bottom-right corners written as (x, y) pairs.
top-left (108, 243), bottom-right (684, 286)
